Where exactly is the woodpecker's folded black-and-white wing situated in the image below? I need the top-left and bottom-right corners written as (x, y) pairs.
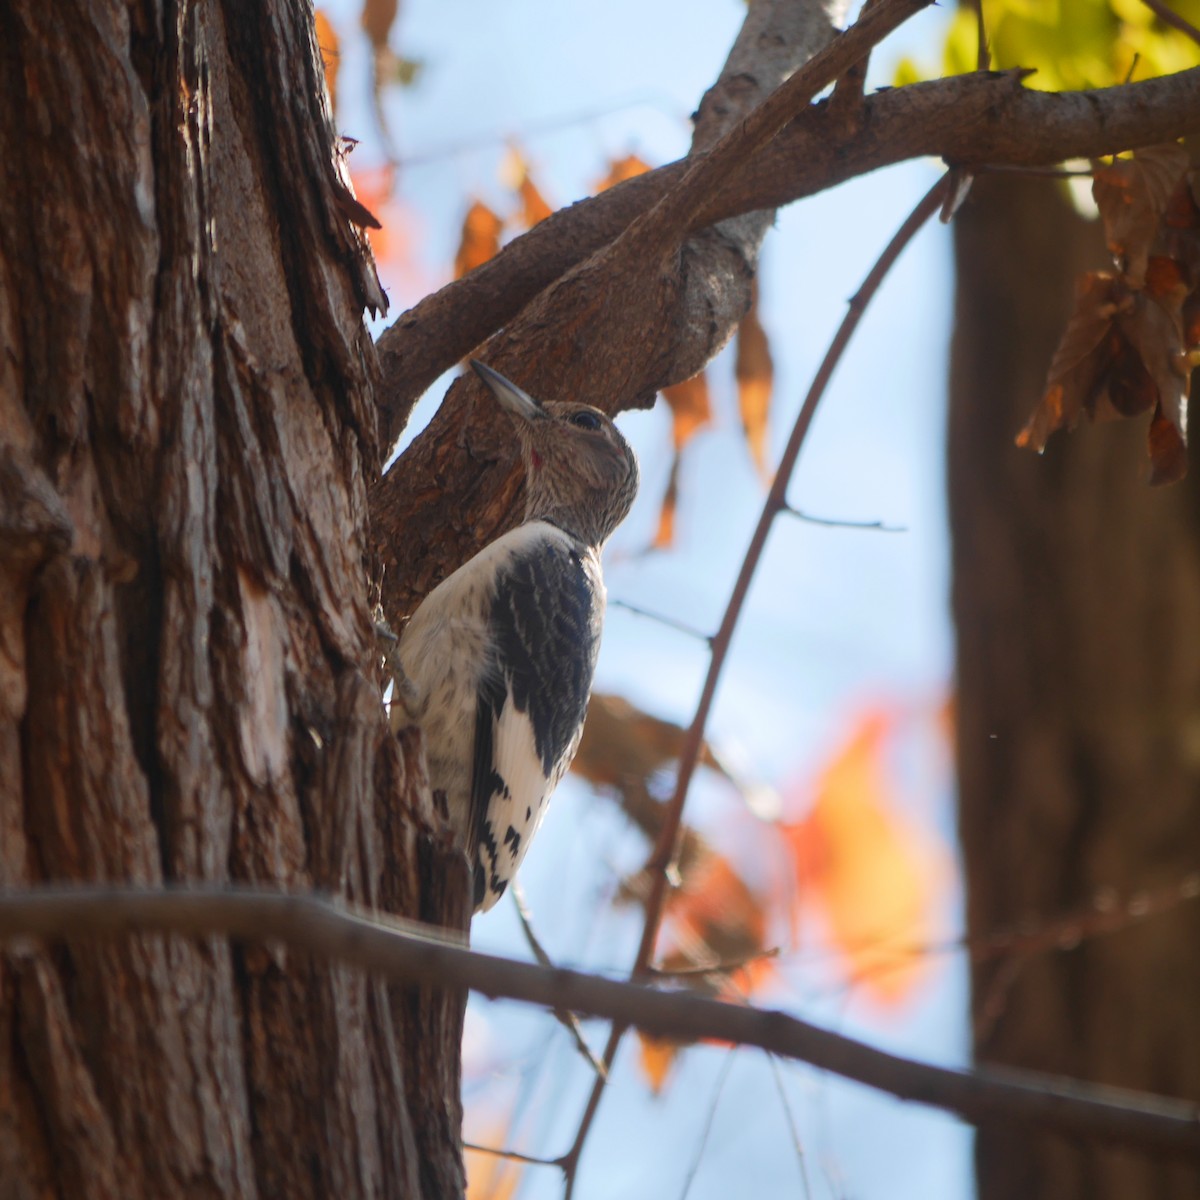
top-left (472, 526), bottom-right (604, 910)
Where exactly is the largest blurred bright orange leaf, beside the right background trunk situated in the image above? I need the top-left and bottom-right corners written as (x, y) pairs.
top-left (782, 712), bottom-right (943, 1006)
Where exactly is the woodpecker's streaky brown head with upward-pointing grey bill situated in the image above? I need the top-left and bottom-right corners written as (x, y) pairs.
top-left (470, 359), bottom-right (637, 547)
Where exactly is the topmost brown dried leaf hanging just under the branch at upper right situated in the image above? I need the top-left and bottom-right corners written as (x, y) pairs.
top-left (1092, 142), bottom-right (1188, 288)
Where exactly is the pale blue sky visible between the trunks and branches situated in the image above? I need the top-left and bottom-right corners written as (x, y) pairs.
top-left (325, 0), bottom-right (972, 1200)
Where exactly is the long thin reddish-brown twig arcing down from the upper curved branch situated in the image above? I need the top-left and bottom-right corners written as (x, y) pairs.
top-left (563, 166), bottom-right (948, 1200)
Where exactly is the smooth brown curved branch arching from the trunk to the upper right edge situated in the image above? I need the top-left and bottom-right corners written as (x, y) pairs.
top-left (378, 67), bottom-right (1200, 440)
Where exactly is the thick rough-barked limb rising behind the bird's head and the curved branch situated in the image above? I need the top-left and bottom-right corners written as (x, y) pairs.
top-left (371, 0), bottom-right (830, 620)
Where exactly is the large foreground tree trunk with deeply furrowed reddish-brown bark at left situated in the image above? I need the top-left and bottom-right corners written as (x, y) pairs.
top-left (0, 0), bottom-right (467, 1200)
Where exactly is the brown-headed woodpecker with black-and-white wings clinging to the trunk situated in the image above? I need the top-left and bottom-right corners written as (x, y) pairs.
top-left (398, 360), bottom-right (637, 912)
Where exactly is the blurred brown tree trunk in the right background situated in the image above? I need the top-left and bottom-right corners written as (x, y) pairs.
top-left (949, 178), bottom-right (1200, 1200)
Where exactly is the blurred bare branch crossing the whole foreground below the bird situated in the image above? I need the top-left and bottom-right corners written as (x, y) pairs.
top-left (0, 887), bottom-right (1200, 1160)
